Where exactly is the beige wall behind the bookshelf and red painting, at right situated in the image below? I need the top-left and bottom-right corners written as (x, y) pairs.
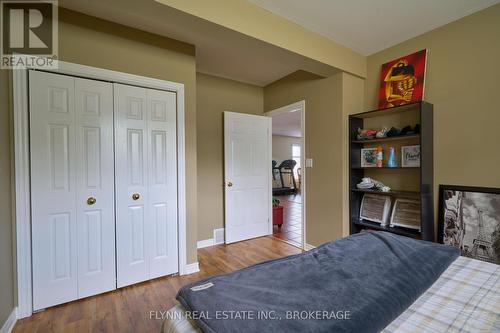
top-left (365, 5), bottom-right (500, 224)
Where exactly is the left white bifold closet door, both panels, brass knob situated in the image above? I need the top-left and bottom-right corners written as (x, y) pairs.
top-left (29, 71), bottom-right (116, 310)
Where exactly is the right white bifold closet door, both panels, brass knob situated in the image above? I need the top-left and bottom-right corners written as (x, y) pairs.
top-left (114, 84), bottom-right (178, 287)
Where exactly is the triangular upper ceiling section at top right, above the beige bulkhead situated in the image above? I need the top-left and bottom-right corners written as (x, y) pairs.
top-left (248, 0), bottom-right (500, 55)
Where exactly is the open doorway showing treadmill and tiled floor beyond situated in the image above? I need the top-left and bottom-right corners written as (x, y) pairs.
top-left (266, 101), bottom-right (306, 249)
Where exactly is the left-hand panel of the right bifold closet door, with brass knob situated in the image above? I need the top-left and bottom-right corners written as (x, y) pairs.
top-left (114, 84), bottom-right (150, 287)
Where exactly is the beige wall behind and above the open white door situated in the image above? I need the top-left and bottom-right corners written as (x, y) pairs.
top-left (196, 73), bottom-right (264, 240)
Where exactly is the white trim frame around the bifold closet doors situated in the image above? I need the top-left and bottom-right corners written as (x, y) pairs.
top-left (12, 61), bottom-right (189, 318)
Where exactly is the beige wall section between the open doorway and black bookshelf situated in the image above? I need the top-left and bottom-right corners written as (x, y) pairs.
top-left (264, 71), bottom-right (344, 245)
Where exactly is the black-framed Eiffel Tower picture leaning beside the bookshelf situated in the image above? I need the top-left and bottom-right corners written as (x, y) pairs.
top-left (438, 185), bottom-right (500, 265)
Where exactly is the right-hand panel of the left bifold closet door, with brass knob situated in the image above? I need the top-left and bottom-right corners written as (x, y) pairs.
top-left (75, 78), bottom-right (116, 298)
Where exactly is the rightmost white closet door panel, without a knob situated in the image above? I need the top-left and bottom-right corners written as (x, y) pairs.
top-left (147, 89), bottom-right (178, 278)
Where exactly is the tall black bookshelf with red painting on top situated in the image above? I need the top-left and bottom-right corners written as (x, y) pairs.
top-left (349, 101), bottom-right (435, 241)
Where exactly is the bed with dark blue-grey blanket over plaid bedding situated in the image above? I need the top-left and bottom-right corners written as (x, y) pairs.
top-left (162, 232), bottom-right (500, 333)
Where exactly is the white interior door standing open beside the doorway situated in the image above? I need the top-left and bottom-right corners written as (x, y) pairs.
top-left (224, 112), bottom-right (272, 243)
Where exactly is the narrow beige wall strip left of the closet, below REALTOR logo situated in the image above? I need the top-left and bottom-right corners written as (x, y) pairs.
top-left (0, 70), bottom-right (15, 326)
